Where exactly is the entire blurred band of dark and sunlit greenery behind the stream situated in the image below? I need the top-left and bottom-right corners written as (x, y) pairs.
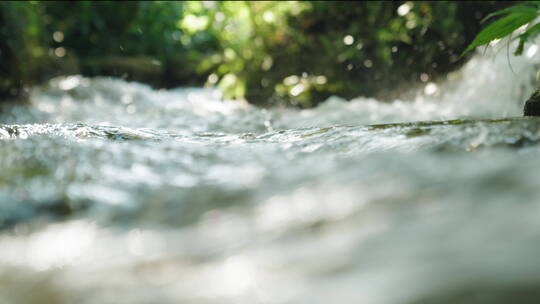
top-left (0, 1), bottom-right (515, 107)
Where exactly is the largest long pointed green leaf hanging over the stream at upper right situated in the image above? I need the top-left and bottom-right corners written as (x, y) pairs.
top-left (460, 9), bottom-right (537, 57)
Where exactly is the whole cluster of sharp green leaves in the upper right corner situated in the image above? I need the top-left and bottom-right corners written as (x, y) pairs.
top-left (462, 1), bottom-right (540, 55)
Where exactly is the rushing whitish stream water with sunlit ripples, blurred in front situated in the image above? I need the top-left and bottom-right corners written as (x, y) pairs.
top-left (0, 46), bottom-right (540, 304)
